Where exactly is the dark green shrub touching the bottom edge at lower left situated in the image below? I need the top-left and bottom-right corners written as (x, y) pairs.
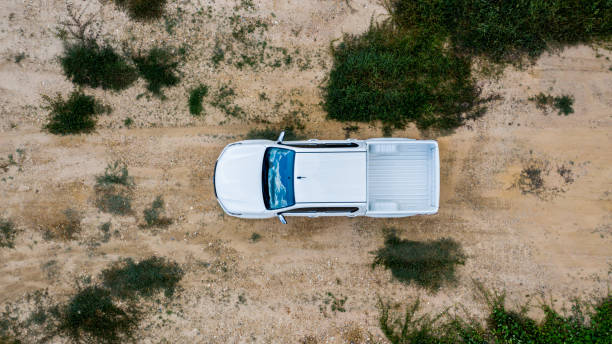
top-left (59, 286), bottom-right (138, 343)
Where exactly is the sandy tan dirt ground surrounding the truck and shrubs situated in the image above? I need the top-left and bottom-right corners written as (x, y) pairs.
top-left (0, 0), bottom-right (612, 343)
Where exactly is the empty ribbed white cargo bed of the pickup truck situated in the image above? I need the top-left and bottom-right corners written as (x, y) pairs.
top-left (367, 139), bottom-right (440, 216)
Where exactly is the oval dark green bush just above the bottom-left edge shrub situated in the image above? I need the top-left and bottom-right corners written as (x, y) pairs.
top-left (101, 257), bottom-right (184, 298)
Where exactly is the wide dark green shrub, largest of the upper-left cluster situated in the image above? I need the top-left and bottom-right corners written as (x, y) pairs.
top-left (60, 40), bottom-right (138, 91)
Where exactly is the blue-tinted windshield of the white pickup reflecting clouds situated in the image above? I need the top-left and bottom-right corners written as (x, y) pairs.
top-left (262, 148), bottom-right (295, 209)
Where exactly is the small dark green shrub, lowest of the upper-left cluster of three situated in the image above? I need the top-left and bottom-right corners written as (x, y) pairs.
top-left (43, 91), bottom-right (104, 135)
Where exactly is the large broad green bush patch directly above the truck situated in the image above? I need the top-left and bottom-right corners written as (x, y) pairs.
top-left (325, 25), bottom-right (484, 129)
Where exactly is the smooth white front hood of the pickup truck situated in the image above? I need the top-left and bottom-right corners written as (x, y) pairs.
top-left (215, 144), bottom-right (266, 214)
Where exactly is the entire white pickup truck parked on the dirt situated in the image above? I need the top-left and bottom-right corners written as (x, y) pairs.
top-left (213, 133), bottom-right (440, 223)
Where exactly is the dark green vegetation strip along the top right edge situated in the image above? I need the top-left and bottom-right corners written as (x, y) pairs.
top-left (386, 0), bottom-right (612, 62)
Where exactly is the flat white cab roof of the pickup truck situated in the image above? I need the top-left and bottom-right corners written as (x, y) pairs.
top-left (294, 152), bottom-right (367, 203)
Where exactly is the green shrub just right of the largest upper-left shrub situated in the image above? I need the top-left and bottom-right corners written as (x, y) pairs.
top-left (132, 47), bottom-right (181, 98)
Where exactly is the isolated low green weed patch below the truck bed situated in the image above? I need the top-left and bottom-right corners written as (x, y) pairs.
top-left (372, 229), bottom-right (466, 291)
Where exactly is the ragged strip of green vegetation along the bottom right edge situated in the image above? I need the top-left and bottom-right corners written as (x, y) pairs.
top-left (379, 295), bottom-right (612, 344)
